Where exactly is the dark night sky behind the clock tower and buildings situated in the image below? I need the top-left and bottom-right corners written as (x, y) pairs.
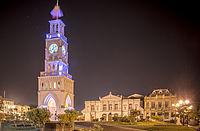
top-left (0, 0), bottom-right (200, 110)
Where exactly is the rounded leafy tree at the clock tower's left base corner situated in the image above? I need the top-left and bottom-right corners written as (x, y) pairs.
top-left (26, 108), bottom-right (50, 127)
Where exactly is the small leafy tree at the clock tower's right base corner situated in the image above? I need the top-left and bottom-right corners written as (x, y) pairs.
top-left (58, 110), bottom-right (78, 128)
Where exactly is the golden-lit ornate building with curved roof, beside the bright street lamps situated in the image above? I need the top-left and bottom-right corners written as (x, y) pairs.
top-left (144, 89), bottom-right (177, 121)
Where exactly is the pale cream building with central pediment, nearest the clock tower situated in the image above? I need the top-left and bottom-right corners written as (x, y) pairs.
top-left (82, 92), bottom-right (143, 121)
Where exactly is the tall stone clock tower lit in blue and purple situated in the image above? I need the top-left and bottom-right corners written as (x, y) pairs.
top-left (38, 3), bottom-right (74, 121)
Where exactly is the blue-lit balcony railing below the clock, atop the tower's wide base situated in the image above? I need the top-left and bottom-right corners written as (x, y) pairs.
top-left (40, 71), bottom-right (72, 79)
